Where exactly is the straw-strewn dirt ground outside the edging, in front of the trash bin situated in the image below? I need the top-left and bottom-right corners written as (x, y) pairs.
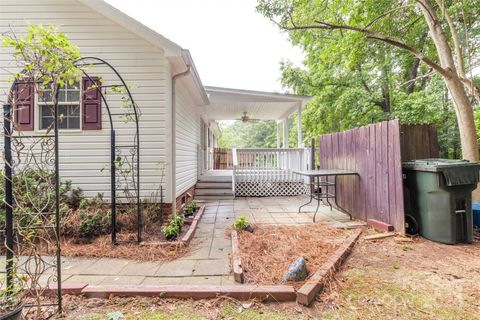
top-left (59, 230), bottom-right (480, 320)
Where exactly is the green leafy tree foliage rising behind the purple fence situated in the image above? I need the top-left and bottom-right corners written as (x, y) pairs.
top-left (257, 0), bottom-right (480, 157)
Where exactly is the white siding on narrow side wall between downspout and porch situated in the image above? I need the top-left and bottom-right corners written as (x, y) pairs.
top-left (175, 81), bottom-right (200, 196)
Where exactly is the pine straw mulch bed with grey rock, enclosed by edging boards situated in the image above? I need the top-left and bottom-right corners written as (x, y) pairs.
top-left (238, 223), bottom-right (349, 287)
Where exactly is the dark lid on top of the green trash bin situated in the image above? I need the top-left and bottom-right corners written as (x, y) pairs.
top-left (402, 159), bottom-right (480, 186)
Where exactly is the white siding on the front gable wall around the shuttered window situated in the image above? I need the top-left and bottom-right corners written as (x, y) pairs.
top-left (0, 0), bottom-right (167, 198)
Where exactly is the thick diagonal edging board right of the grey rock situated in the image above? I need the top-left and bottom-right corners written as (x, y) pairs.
top-left (297, 229), bottom-right (362, 306)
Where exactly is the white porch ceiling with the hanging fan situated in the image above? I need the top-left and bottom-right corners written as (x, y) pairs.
top-left (202, 87), bottom-right (311, 121)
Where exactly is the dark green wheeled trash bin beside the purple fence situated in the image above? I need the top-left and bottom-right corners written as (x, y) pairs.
top-left (402, 159), bottom-right (480, 244)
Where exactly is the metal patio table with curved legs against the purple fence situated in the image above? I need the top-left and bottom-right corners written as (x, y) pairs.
top-left (293, 169), bottom-right (358, 222)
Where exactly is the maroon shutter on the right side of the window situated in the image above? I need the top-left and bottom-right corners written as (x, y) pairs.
top-left (82, 77), bottom-right (102, 130)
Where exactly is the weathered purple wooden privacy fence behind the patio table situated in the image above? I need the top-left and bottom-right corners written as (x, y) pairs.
top-left (318, 120), bottom-right (438, 232)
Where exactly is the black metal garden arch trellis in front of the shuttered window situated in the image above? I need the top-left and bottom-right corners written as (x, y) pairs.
top-left (4, 57), bottom-right (142, 313)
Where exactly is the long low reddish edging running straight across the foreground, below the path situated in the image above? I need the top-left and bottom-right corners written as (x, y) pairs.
top-left (43, 284), bottom-right (296, 301)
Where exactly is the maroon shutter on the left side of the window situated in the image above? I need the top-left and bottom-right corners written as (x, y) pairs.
top-left (13, 80), bottom-right (35, 131)
